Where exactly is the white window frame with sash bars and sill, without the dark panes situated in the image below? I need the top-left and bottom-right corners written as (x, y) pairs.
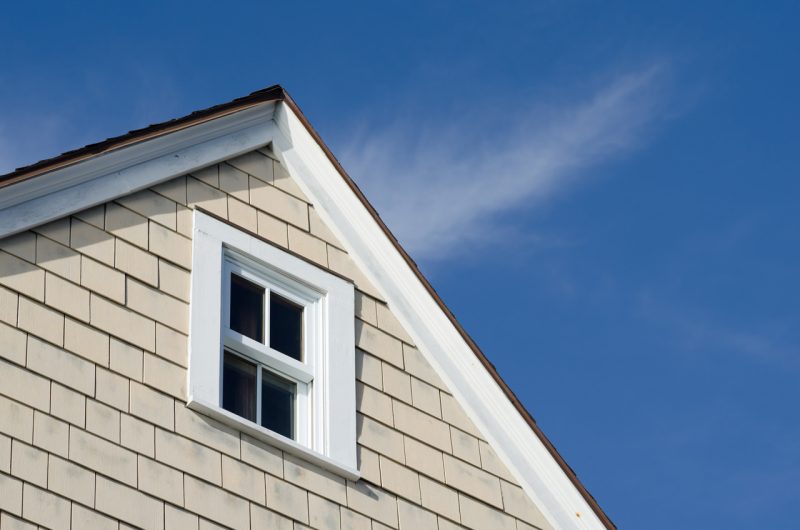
top-left (187, 210), bottom-right (359, 480)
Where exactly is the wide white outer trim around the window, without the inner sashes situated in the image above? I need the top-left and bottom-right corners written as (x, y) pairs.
top-left (187, 209), bottom-right (360, 480)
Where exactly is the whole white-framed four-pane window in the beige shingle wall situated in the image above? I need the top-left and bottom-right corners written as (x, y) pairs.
top-left (188, 210), bottom-right (357, 478)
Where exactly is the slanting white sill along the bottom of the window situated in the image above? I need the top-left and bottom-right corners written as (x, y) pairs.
top-left (187, 400), bottom-right (361, 481)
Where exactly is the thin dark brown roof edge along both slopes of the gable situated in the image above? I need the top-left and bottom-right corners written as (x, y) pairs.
top-left (0, 85), bottom-right (616, 529)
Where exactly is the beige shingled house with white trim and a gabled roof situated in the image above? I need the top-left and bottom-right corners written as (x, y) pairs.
top-left (0, 86), bottom-right (614, 530)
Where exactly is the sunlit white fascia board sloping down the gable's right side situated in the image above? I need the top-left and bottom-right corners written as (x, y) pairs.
top-left (273, 103), bottom-right (605, 530)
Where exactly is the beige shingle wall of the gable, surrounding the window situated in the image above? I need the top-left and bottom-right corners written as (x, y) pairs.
top-left (0, 147), bottom-right (547, 530)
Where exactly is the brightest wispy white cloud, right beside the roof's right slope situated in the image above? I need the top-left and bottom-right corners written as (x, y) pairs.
top-left (342, 66), bottom-right (665, 260)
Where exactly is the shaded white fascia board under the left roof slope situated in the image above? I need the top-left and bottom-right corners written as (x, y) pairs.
top-left (0, 102), bottom-right (275, 238)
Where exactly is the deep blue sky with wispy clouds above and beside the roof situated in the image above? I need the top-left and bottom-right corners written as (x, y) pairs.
top-left (0, 1), bottom-right (800, 530)
